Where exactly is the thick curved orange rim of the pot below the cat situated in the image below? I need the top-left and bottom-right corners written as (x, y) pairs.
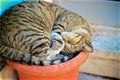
top-left (7, 51), bottom-right (89, 76)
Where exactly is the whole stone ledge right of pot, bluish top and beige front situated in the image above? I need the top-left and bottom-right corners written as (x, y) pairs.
top-left (80, 24), bottom-right (120, 79)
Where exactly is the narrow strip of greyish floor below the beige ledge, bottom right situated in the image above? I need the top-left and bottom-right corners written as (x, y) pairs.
top-left (79, 73), bottom-right (119, 80)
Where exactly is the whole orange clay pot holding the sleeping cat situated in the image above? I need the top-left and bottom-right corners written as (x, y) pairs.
top-left (7, 52), bottom-right (89, 80)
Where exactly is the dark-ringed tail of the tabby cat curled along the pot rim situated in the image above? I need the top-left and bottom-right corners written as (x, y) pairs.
top-left (0, 44), bottom-right (69, 67)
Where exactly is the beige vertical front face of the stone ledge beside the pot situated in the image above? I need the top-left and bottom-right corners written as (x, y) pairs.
top-left (80, 50), bottom-right (120, 79)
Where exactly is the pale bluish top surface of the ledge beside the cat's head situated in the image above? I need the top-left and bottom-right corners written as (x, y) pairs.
top-left (90, 25), bottom-right (120, 53)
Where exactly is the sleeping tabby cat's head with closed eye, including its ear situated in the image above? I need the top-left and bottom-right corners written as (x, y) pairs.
top-left (62, 29), bottom-right (93, 53)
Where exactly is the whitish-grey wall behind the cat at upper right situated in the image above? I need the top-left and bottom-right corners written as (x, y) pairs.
top-left (57, 0), bottom-right (120, 28)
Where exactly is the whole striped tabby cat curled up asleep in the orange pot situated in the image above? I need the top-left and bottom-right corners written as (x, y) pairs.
top-left (0, 1), bottom-right (93, 70)
